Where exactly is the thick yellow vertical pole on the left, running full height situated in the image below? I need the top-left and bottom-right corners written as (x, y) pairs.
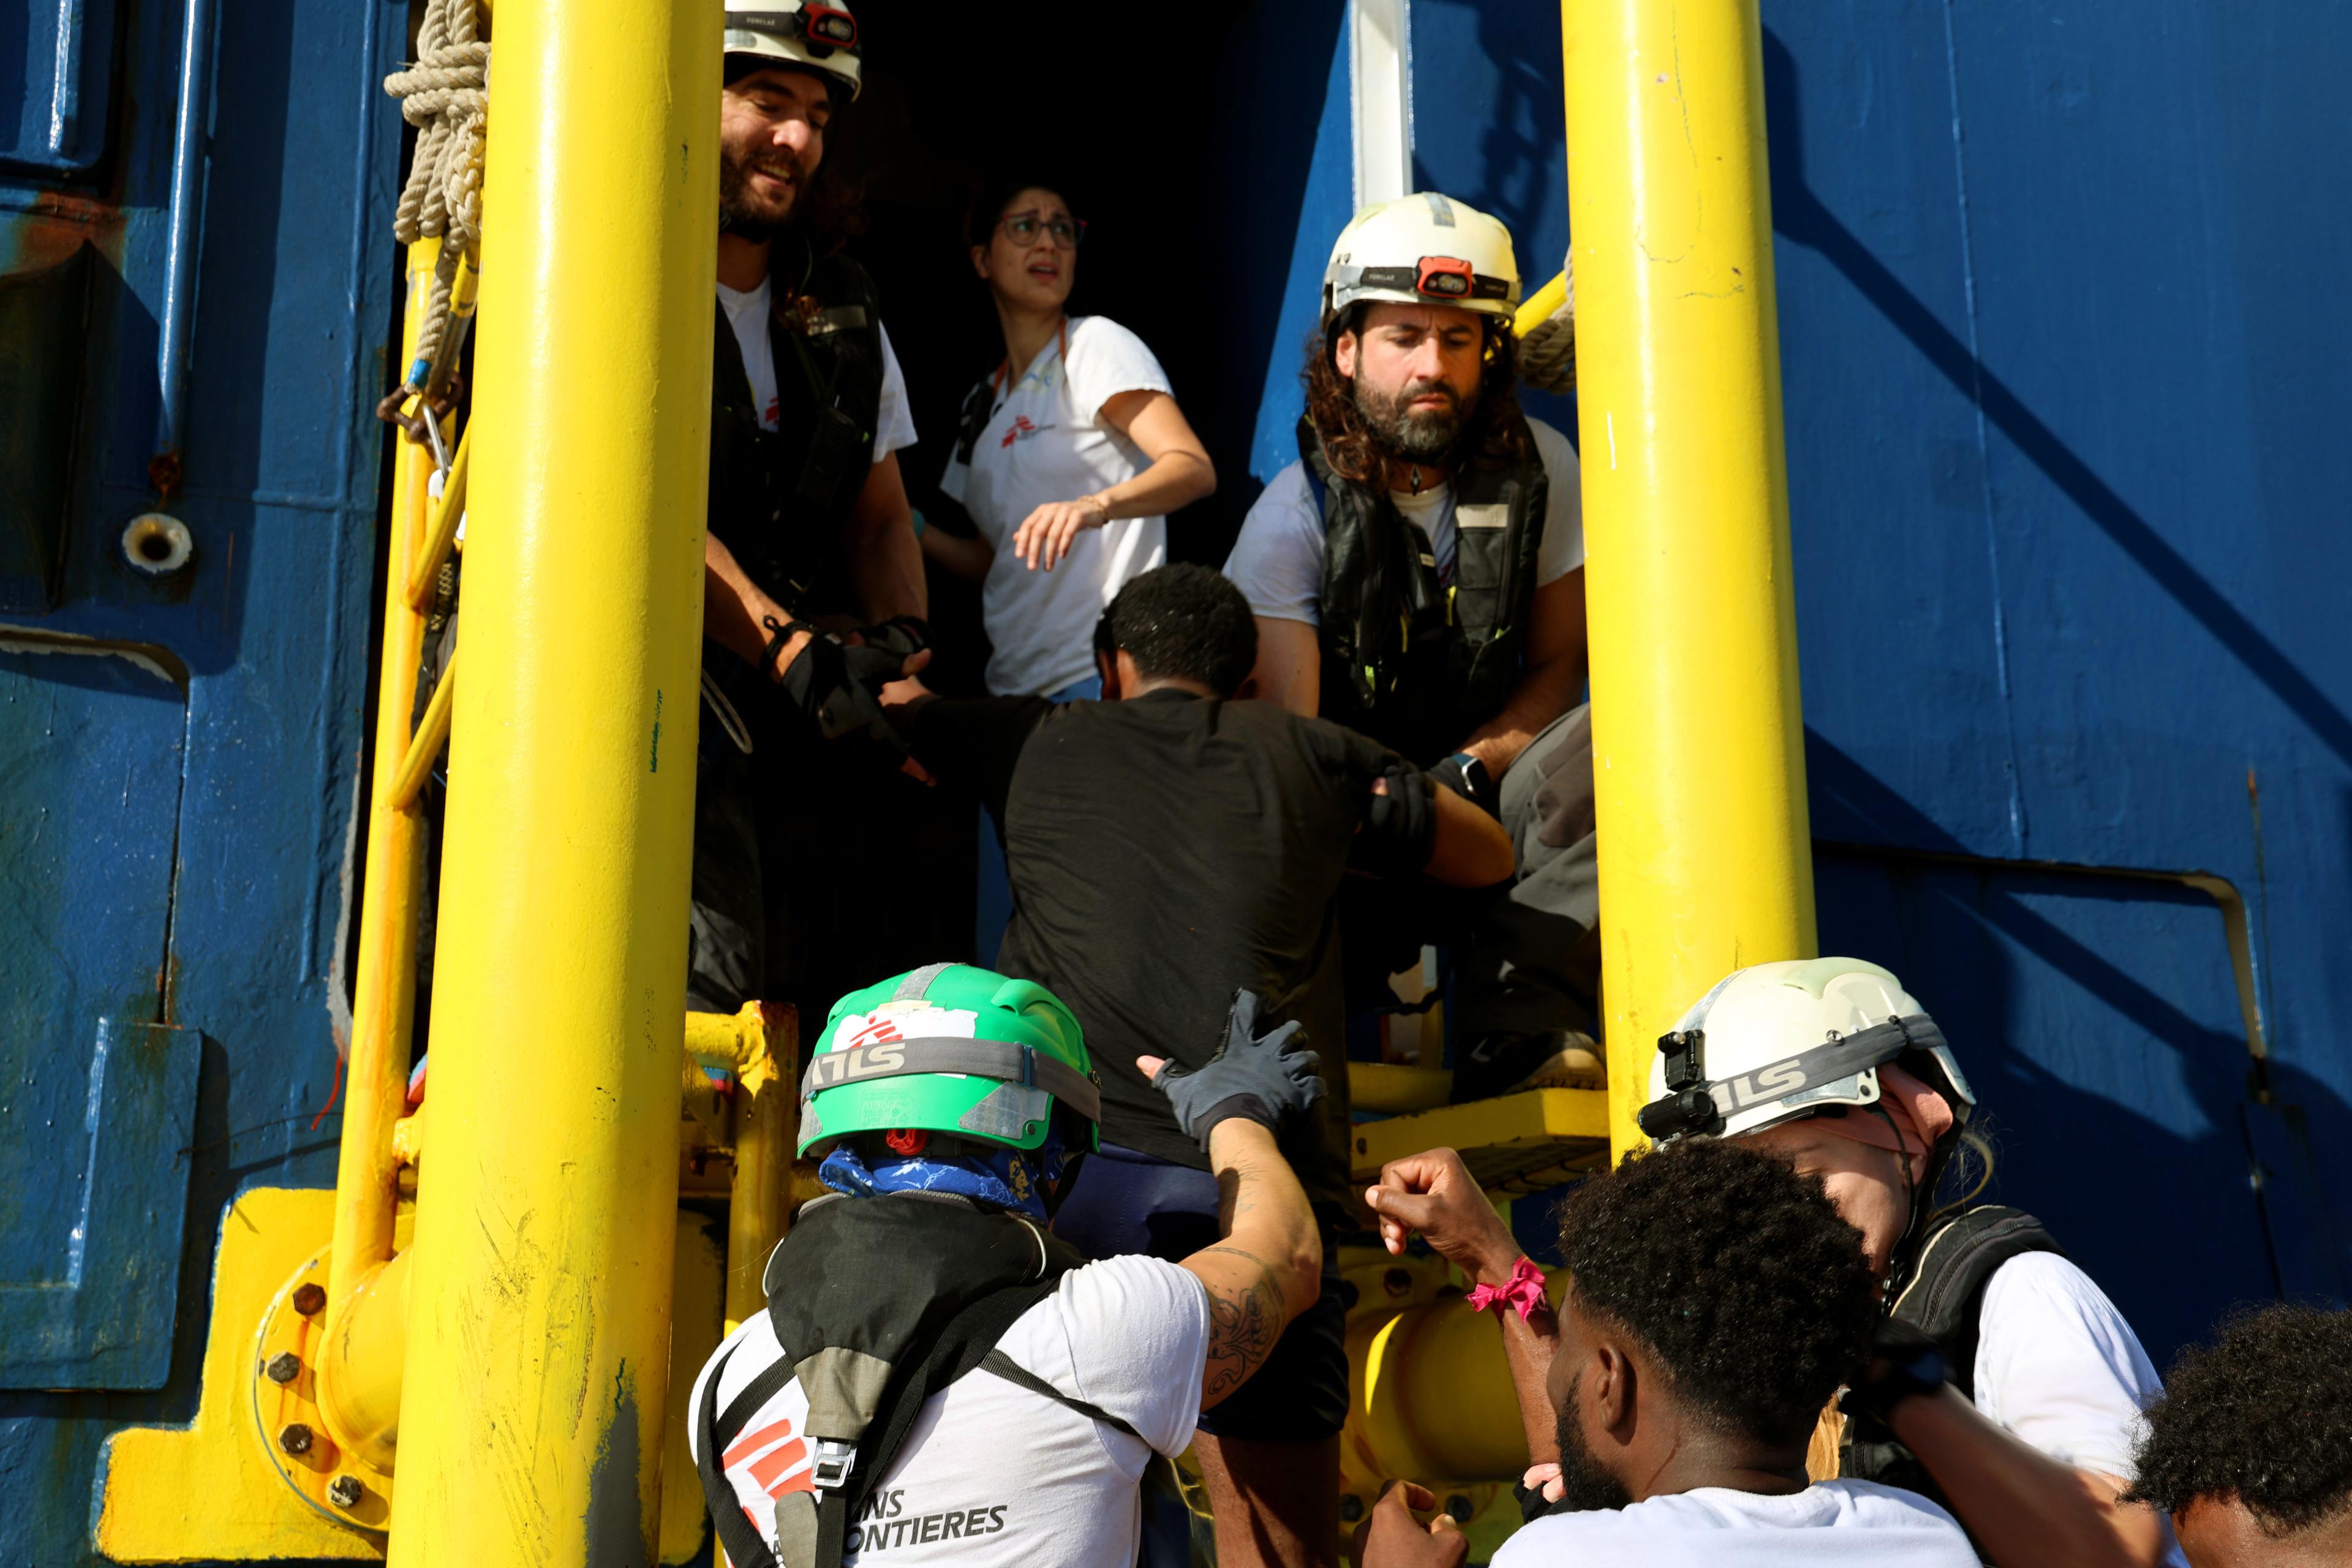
top-left (390, 0), bottom-right (720, 1568)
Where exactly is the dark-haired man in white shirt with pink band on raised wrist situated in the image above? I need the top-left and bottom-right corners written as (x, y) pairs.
top-left (1357, 1138), bottom-right (1976, 1568)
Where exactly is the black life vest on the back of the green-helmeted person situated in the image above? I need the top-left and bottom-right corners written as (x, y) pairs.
top-left (694, 1192), bottom-right (1136, 1568)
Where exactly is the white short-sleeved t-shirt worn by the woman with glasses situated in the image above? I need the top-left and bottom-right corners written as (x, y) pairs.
top-left (938, 315), bottom-right (1169, 696)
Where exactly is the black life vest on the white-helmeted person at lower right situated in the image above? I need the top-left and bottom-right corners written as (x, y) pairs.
top-left (1839, 1204), bottom-right (2065, 1509)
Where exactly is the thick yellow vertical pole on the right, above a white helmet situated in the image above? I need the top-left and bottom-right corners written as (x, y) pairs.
top-left (1562, 0), bottom-right (1814, 1154)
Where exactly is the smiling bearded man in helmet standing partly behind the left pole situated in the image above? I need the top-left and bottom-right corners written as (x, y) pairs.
top-left (687, 0), bottom-right (927, 1013)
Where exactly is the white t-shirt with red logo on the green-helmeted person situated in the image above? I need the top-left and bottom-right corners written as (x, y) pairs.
top-left (689, 1257), bottom-right (1209, 1568)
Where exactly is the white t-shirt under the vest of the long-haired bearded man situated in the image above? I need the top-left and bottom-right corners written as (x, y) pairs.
top-left (1226, 418), bottom-right (1585, 625)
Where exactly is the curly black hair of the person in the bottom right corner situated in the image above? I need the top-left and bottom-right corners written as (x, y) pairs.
top-left (2124, 1307), bottom-right (2352, 1535)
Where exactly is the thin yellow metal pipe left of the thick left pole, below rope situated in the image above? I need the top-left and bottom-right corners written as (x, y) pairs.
top-left (327, 239), bottom-right (440, 1363)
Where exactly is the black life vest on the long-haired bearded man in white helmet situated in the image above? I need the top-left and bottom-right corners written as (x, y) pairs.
top-left (1298, 418), bottom-right (1550, 764)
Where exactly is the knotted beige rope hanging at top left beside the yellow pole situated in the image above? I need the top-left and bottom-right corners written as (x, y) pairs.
top-left (383, 0), bottom-right (489, 390)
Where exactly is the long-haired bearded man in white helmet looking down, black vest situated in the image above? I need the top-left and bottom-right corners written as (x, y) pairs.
top-left (1226, 193), bottom-right (1599, 1100)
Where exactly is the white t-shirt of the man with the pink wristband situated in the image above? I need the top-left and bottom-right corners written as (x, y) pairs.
top-left (1493, 1481), bottom-right (1978, 1568)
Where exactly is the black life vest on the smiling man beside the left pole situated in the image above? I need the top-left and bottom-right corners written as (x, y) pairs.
top-left (710, 239), bottom-right (882, 614)
